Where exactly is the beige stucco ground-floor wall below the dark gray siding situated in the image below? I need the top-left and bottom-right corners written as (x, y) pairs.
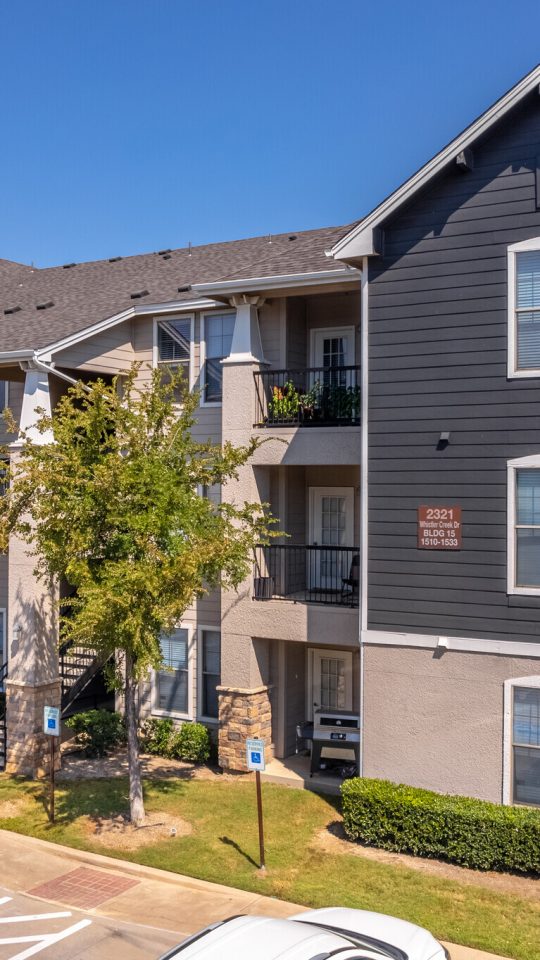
top-left (363, 644), bottom-right (540, 803)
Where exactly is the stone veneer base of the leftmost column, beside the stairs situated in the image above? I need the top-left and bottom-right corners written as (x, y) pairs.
top-left (5, 680), bottom-right (61, 777)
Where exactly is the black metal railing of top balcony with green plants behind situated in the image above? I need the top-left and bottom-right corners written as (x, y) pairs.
top-left (254, 366), bottom-right (360, 427)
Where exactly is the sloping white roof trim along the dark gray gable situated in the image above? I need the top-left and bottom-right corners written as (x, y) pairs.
top-left (330, 66), bottom-right (540, 260)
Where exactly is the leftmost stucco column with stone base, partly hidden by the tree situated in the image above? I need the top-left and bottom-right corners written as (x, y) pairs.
top-left (6, 368), bottom-right (61, 776)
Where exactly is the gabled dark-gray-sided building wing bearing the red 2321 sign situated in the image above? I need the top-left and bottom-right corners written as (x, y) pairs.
top-left (333, 67), bottom-right (540, 805)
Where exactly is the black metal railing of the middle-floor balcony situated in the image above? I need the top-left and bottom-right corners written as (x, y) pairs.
top-left (253, 544), bottom-right (360, 607)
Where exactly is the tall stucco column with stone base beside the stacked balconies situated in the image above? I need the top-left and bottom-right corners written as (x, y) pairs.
top-left (218, 296), bottom-right (271, 770)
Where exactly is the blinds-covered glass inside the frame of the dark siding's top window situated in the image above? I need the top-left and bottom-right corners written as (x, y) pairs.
top-left (515, 249), bottom-right (540, 370)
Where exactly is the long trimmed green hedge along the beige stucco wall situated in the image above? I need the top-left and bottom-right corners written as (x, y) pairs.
top-left (341, 777), bottom-right (540, 874)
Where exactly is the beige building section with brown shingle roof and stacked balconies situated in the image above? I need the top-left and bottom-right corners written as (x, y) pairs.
top-left (0, 228), bottom-right (360, 772)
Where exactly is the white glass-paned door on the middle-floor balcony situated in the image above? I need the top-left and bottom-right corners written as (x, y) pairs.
top-left (308, 487), bottom-right (354, 591)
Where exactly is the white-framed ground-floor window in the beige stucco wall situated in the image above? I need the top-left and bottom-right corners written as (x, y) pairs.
top-left (503, 676), bottom-right (540, 807)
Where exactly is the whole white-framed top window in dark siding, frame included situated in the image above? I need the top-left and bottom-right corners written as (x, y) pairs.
top-left (508, 237), bottom-right (540, 377)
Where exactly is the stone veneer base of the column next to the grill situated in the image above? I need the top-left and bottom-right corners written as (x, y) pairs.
top-left (217, 686), bottom-right (272, 771)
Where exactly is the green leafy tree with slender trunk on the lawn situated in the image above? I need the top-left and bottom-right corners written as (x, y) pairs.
top-left (0, 365), bottom-right (273, 822)
